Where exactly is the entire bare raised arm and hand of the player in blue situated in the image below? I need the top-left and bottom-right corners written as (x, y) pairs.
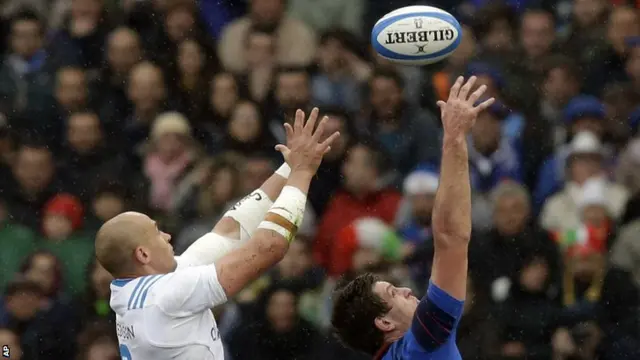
top-left (431, 77), bottom-right (494, 300)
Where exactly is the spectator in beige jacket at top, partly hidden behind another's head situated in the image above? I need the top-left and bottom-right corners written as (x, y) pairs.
top-left (218, 0), bottom-right (316, 73)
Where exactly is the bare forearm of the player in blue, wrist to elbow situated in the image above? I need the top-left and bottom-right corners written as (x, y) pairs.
top-left (433, 134), bottom-right (471, 246)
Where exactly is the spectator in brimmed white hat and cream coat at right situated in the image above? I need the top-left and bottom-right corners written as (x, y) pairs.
top-left (540, 131), bottom-right (629, 231)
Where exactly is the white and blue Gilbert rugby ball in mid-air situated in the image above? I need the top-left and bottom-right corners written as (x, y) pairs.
top-left (371, 5), bottom-right (462, 65)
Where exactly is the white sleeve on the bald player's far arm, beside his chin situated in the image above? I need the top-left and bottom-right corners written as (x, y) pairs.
top-left (180, 232), bottom-right (241, 266)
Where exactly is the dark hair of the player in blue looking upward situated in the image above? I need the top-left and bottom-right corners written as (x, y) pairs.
top-left (331, 274), bottom-right (390, 355)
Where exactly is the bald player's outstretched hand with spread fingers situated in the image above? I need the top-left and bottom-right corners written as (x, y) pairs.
top-left (276, 108), bottom-right (340, 174)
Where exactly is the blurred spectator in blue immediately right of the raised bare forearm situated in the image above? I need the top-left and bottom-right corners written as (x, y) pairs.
top-left (469, 102), bottom-right (522, 197)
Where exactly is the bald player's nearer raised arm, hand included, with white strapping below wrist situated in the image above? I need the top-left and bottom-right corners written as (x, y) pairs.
top-left (215, 109), bottom-right (339, 297)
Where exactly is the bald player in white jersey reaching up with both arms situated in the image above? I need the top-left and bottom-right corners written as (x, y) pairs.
top-left (96, 109), bottom-right (339, 360)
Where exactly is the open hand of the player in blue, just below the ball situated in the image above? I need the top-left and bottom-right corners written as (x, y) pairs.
top-left (437, 76), bottom-right (495, 137)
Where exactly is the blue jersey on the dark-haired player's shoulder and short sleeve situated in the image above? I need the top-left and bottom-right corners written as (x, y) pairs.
top-left (376, 283), bottom-right (464, 360)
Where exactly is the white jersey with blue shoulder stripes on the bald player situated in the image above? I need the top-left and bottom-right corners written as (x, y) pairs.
top-left (110, 257), bottom-right (227, 360)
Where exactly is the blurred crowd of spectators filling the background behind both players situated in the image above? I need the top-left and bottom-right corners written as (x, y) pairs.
top-left (0, 0), bottom-right (640, 360)
